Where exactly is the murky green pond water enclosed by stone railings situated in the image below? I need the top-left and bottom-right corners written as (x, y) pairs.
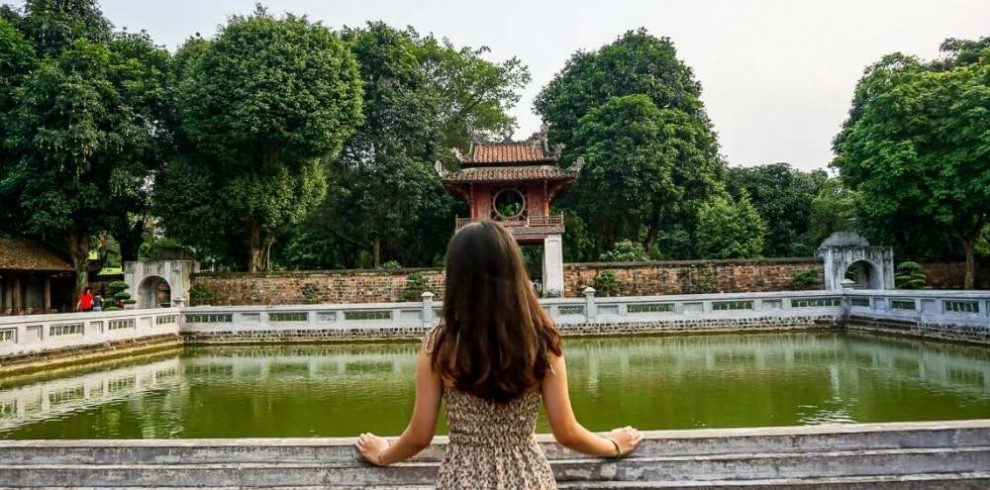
top-left (0, 332), bottom-right (990, 439)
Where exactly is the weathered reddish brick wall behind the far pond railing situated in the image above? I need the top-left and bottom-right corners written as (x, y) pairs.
top-left (193, 258), bottom-right (990, 305)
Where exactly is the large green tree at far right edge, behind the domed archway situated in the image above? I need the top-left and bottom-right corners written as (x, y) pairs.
top-left (832, 39), bottom-right (990, 288)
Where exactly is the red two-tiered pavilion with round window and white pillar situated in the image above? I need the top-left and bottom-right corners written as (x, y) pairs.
top-left (436, 135), bottom-right (583, 296)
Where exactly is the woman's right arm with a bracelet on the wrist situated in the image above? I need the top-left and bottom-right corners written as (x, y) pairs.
top-left (542, 355), bottom-right (643, 457)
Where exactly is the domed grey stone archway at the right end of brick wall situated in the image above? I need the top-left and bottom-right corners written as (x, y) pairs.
top-left (817, 232), bottom-right (894, 290)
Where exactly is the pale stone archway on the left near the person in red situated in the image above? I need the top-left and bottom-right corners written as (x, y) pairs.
top-left (124, 260), bottom-right (199, 308)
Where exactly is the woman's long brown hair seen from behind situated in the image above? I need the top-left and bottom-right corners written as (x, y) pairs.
top-left (432, 221), bottom-right (561, 403)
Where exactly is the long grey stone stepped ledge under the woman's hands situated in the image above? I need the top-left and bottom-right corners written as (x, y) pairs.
top-left (0, 420), bottom-right (990, 490)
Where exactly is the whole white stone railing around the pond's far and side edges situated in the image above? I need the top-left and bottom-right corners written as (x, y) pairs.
top-left (0, 288), bottom-right (990, 363)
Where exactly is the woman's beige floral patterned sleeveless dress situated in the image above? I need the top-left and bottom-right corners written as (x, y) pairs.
top-left (437, 388), bottom-right (557, 490)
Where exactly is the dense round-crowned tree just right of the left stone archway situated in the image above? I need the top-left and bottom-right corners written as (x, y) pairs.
top-left (156, 7), bottom-right (361, 271)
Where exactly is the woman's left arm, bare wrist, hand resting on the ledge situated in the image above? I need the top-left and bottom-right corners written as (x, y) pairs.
top-left (357, 346), bottom-right (443, 466)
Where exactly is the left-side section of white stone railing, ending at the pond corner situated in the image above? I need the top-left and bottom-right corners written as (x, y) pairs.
top-left (0, 308), bottom-right (182, 365)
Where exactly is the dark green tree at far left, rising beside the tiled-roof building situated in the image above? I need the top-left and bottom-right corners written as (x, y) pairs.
top-left (0, 34), bottom-right (169, 294)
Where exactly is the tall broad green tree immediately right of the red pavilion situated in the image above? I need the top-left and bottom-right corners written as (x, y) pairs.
top-left (535, 29), bottom-right (723, 257)
